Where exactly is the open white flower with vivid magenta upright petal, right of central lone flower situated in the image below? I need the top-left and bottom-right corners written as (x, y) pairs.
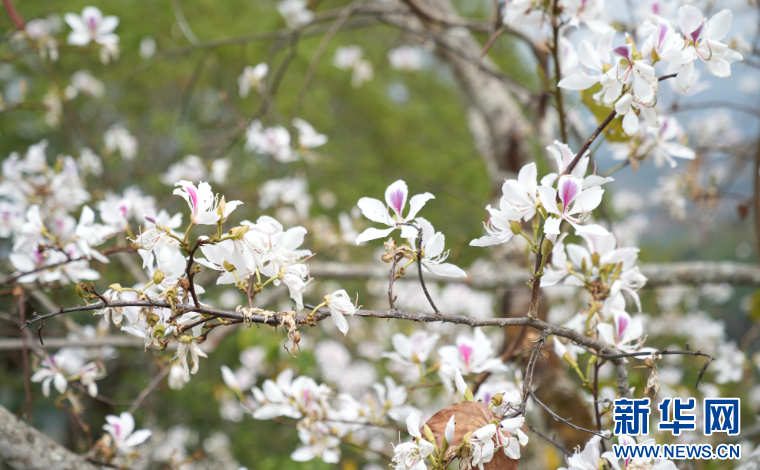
top-left (538, 175), bottom-right (608, 235)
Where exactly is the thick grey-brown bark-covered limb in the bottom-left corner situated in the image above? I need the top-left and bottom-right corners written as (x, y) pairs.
top-left (0, 406), bottom-right (98, 470)
